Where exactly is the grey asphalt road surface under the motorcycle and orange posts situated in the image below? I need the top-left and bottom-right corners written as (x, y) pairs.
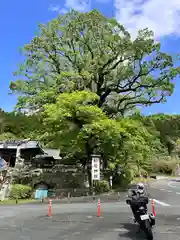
top-left (0, 180), bottom-right (180, 240)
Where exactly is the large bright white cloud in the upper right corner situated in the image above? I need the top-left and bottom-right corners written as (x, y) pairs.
top-left (114, 0), bottom-right (180, 38)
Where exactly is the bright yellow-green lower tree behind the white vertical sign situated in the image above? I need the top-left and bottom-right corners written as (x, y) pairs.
top-left (42, 91), bottom-right (158, 184)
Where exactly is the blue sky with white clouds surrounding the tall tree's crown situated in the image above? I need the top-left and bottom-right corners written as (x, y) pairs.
top-left (0, 0), bottom-right (180, 113)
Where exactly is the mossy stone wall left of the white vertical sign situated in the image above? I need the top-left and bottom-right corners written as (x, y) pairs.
top-left (11, 165), bottom-right (87, 189)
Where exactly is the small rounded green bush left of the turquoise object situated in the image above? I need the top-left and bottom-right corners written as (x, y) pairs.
top-left (10, 184), bottom-right (32, 199)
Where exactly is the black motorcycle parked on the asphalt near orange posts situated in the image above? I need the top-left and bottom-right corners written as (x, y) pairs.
top-left (126, 197), bottom-right (155, 240)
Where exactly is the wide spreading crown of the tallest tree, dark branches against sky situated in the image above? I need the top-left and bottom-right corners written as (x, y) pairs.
top-left (10, 10), bottom-right (179, 116)
